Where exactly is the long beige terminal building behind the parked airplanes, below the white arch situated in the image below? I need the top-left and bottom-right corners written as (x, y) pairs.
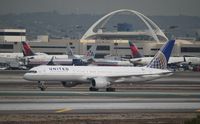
top-left (0, 34), bottom-right (200, 58)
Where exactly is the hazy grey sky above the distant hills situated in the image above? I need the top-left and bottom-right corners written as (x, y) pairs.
top-left (0, 0), bottom-right (200, 16)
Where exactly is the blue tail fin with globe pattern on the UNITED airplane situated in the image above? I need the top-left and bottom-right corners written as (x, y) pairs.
top-left (147, 40), bottom-right (175, 69)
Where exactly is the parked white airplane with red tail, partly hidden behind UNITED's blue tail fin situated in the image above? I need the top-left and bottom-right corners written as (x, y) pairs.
top-left (129, 41), bottom-right (185, 66)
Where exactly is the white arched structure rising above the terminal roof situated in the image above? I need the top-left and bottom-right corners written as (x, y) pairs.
top-left (81, 9), bottom-right (168, 42)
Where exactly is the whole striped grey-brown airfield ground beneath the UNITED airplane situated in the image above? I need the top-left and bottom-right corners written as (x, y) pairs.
top-left (0, 71), bottom-right (200, 123)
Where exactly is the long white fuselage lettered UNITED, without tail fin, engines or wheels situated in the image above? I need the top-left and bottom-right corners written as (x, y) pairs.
top-left (24, 65), bottom-right (172, 83)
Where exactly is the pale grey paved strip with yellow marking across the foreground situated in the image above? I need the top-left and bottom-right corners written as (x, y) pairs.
top-left (0, 98), bottom-right (200, 113)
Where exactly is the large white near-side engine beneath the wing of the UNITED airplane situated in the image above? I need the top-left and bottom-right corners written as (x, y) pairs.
top-left (91, 77), bottom-right (110, 88)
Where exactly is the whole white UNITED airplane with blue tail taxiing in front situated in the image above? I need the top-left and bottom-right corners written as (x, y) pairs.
top-left (23, 40), bottom-right (175, 91)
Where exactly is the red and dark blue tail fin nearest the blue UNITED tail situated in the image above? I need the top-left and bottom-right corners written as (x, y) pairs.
top-left (128, 41), bottom-right (143, 58)
